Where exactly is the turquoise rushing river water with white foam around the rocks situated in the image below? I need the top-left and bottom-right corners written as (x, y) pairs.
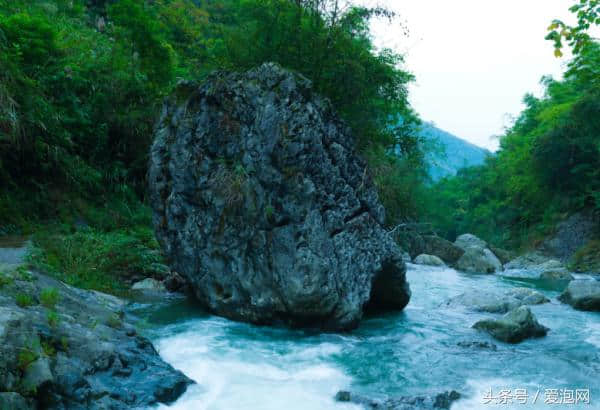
top-left (135, 265), bottom-right (600, 410)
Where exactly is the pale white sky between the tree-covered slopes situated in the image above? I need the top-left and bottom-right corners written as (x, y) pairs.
top-left (360, 0), bottom-right (574, 150)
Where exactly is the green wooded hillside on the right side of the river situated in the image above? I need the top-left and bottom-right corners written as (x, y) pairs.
top-left (427, 1), bottom-right (600, 249)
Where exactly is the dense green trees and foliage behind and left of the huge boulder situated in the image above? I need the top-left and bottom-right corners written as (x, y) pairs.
top-left (0, 0), bottom-right (423, 230)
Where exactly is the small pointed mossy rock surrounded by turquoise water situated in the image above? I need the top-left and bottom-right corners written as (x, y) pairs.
top-left (473, 306), bottom-right (549, 343)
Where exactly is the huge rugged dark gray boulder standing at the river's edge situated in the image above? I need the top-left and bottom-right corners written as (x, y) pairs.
top-left (149, 63), bottom-right (410, 330)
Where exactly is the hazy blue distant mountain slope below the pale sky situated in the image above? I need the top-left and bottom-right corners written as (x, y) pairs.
top-left (421, 123), bottom-right (491, 181)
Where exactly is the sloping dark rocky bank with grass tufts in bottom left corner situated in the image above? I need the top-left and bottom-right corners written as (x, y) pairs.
top-left (0, 272), bottom-right (192, 410)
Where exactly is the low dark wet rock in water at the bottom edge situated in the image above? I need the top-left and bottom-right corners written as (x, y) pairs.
top-left (335, 390), bottom-right (461, 410)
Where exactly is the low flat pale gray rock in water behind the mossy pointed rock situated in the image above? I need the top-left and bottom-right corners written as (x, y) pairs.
top-left (446, 288), bottom-right (550, 313)
